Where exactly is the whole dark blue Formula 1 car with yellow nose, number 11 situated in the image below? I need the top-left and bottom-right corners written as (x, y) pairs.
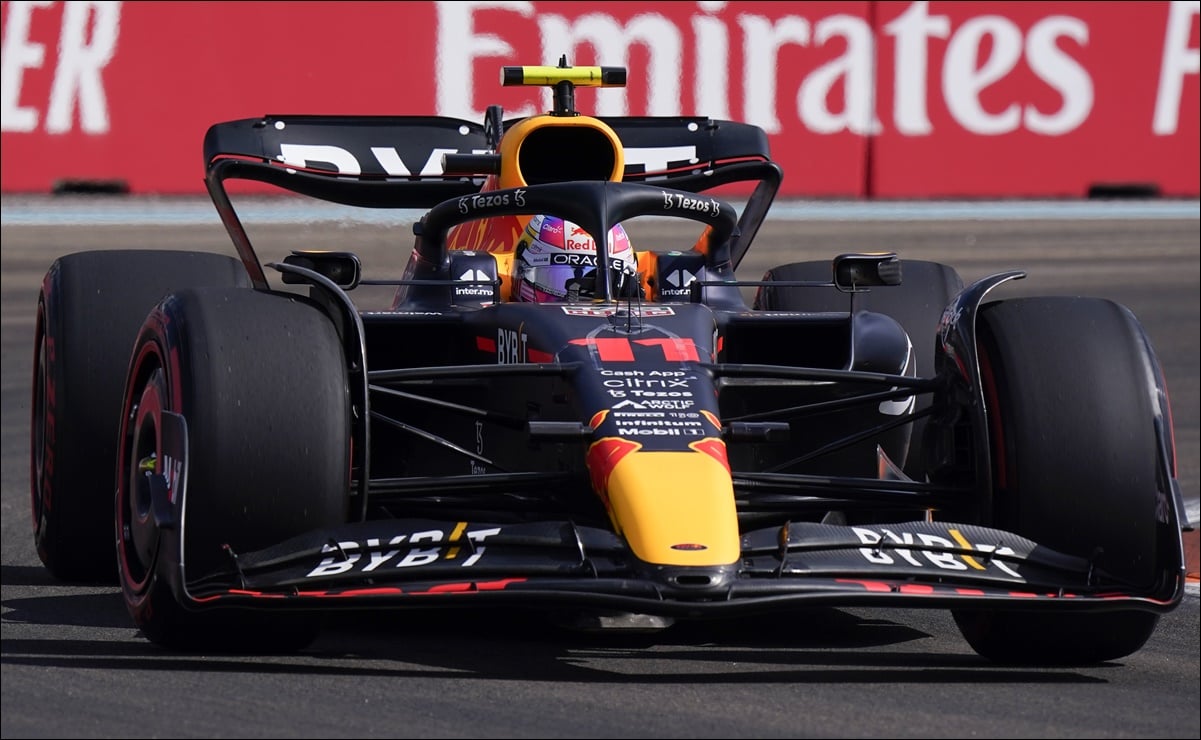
top-left (31, 60), bottom-right (1189, 664)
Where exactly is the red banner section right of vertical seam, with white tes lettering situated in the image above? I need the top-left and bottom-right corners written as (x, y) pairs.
top-left (868, 2), bottom-right (1201, 197)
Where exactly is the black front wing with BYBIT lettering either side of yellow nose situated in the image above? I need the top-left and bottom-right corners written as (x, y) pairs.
top-left (179, 519), bottom-right (1183, 617)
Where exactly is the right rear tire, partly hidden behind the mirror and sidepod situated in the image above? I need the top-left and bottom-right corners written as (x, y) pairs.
top-left (754, 259), bottom-right (963, 479)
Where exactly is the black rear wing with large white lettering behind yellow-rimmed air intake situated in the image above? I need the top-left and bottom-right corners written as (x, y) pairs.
top-left (204, 115), bottom-right (783, 286)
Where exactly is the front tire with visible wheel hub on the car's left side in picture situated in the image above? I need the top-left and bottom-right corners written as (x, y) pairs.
top-left (116, 288), bottom-right (351, 652)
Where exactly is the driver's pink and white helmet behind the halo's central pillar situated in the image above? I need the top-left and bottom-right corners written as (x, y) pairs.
top-left (513, 215), bottom-right (639, 303)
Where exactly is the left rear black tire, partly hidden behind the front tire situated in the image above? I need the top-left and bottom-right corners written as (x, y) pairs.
top-left (29, 250), bottom-right (250, 584)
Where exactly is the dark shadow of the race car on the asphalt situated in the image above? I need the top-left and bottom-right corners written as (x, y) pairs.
top-left (0, 567), bottom-right (1104, 685)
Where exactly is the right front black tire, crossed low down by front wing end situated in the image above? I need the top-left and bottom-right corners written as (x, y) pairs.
top-left (954, 297), bottom-right (1161, 664)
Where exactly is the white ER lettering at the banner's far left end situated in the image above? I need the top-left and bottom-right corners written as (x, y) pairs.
top-left (0, 1), bottom-right (121, 135)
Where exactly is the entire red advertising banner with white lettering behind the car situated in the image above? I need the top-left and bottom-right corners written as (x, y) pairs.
top-left (0, 0), bottom-right (1201, 198)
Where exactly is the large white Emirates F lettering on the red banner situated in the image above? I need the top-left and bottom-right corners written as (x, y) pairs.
top-left (437, 0), bottom-right (1114, 137)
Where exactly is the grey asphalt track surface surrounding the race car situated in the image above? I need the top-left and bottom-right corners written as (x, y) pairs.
top-left (0, 198), bottom-right (1201, 738)
